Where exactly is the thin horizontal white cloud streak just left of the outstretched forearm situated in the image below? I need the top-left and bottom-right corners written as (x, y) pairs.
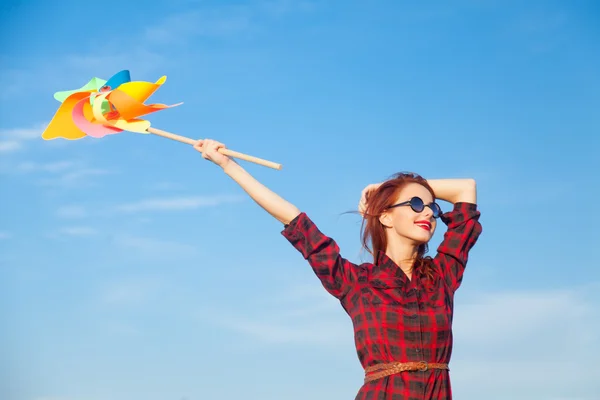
top-left (116, 196), bottom-right (244, 213)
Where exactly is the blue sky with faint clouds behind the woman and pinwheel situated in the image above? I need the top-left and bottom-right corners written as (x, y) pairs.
top-left (0, 0), bottom-right (600, 400)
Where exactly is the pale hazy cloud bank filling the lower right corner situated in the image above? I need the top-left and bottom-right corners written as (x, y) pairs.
top-left (453, 284), bottom-right (600, 399)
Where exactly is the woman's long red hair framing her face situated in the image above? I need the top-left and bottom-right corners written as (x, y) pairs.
top-left (361, 172), bottom-right (435, 279)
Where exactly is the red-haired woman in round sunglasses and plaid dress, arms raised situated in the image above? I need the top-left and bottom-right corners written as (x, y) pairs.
top-left (195, 140), bottom-right (481, 400)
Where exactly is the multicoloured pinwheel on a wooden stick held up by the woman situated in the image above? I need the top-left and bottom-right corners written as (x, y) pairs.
top-left (42, 70), bottom-right (281, 170)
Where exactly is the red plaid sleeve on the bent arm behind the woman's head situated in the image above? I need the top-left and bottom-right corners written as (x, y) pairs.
top-left (433, 203), bottom-right (482, 292)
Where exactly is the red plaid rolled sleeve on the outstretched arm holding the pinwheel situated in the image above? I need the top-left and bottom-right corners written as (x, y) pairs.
top-left (281, 213), bottom-right (358, 299)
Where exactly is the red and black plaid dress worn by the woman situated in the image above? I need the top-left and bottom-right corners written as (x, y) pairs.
top-left (281, 203), bottom-right (482, 400)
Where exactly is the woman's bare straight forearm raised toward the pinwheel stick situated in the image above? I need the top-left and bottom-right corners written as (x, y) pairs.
top-left (223, 160), bottom-right (300, 225)
